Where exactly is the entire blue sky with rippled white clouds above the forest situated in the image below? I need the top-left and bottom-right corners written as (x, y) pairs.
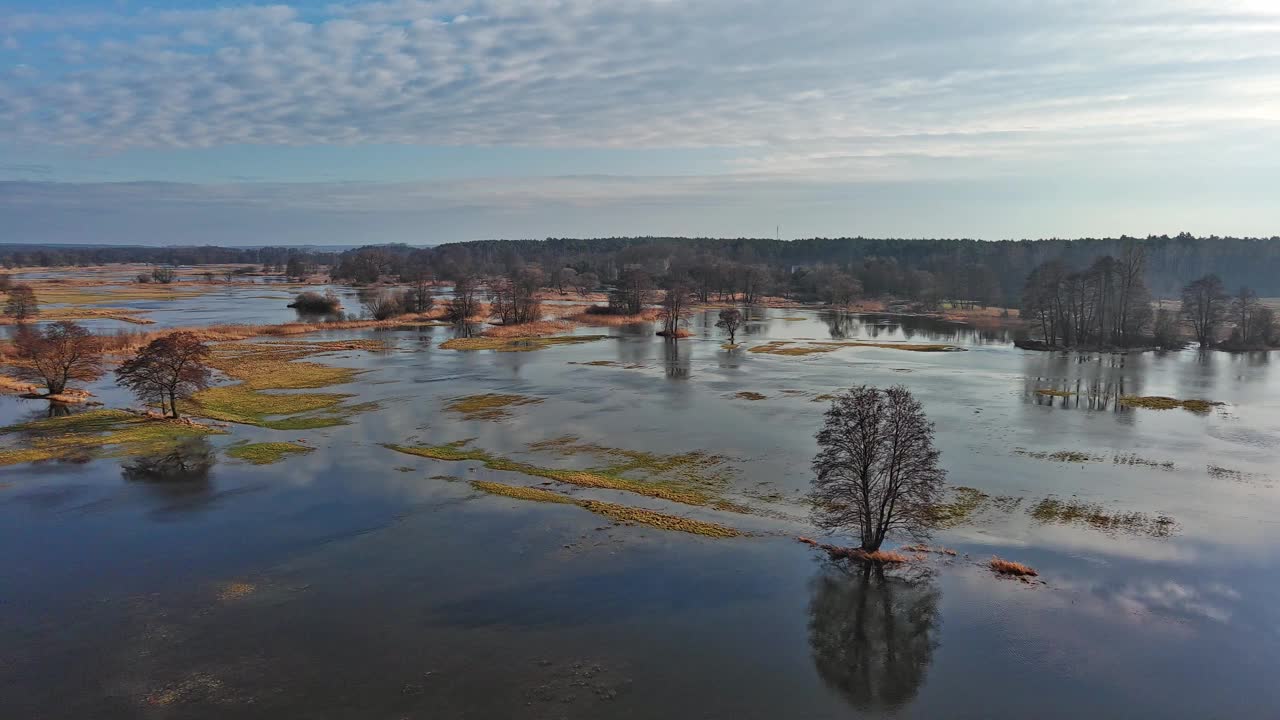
top-left (0, 0), bottom-right (1280, 245)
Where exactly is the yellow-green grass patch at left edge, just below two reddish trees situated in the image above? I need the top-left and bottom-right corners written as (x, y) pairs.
top-left (0, 410), bottom-right (220, 465)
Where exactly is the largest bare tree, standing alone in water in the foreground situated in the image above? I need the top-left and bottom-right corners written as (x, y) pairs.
top-left (810, 386), bottom-right (946, 552)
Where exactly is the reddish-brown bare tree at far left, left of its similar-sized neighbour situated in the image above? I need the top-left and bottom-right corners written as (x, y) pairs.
top-left (13, 320), bottom-right (102, 395)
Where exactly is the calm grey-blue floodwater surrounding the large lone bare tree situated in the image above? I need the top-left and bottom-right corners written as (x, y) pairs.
top-left (0, 288), bottom-right (1280, 719)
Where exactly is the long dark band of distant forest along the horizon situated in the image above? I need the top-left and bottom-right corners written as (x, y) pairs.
top-left (0, 233), bottom-right (1280, 299)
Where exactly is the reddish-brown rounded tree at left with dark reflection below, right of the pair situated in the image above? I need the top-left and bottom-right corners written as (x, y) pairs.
top-left (115, 331), bottom-right (211, 418)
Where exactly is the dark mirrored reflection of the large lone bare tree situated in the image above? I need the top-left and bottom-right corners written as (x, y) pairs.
top-left (809, 564), bottom-right (941, 711)
